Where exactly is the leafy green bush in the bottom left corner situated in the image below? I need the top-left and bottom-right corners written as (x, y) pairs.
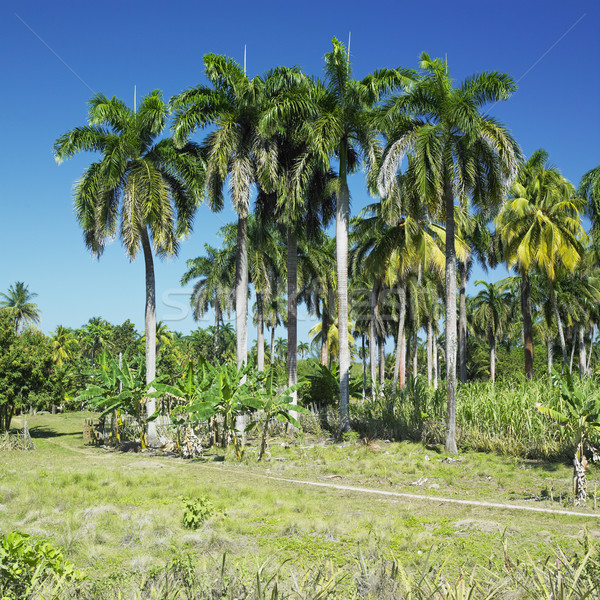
top-left (0, 531), bottom-right (85, 600)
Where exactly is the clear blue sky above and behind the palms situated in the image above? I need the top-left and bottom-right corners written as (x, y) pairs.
top-left (0, 0), bottom-right (600, 339)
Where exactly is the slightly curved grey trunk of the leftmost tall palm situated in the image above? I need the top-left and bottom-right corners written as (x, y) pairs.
top-left (140, 227), bottom-right (158, 448)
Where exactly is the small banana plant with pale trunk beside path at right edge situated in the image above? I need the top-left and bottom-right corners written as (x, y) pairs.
top-left (535, 369), bottom-right (600, 506)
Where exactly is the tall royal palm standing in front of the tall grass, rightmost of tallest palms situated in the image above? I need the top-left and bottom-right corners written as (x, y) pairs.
top-left (379, 53), bottom-right (520, 453)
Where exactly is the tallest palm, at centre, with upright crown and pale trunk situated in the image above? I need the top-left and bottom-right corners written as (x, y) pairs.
top-left (314, 38), bottom-right (412, 431)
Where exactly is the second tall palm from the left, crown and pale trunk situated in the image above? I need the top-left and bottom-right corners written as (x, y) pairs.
top-left (171, 54), bottom-right (299, 368)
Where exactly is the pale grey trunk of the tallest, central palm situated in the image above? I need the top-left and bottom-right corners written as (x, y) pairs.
top-left (335, 138), bottom-right (350, 432)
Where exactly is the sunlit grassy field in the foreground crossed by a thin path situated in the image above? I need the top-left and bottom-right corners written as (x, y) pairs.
top-left (0, 413), bottom-right (600, 596)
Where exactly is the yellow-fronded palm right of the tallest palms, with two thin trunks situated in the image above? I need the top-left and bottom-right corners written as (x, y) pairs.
top-left (496, 150), bottom-right (586, 377)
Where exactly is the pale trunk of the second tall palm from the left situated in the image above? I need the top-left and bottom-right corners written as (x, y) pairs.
top-left (235, 214), bottom-right (248, 369)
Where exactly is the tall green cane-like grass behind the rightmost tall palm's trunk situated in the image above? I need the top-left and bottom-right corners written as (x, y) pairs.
top-left (352, 378), bottom-right (598, 459)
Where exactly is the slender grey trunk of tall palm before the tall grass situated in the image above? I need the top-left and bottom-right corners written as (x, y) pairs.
top-left (444, 172), bottom-right (458, 454)
